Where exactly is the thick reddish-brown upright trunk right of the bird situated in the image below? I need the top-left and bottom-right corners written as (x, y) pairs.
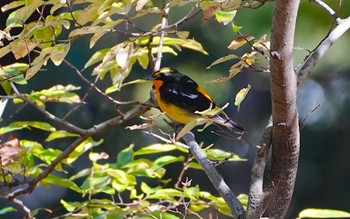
top-left (267, 0), bottom-right (300, 218)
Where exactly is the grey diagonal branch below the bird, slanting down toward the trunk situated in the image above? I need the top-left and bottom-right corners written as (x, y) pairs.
top-left (183, 132), bottom-right (245, 218)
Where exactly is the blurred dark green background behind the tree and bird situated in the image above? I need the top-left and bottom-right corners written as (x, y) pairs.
top-left (1, 0), bottom-right (350, 218)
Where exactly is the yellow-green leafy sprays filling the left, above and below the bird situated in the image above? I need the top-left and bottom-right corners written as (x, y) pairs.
top-left (0, 0), bottom-right (247, 218)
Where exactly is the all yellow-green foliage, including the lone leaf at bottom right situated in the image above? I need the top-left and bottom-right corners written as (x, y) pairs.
top-left (0, 0), bottom-right (348, 219)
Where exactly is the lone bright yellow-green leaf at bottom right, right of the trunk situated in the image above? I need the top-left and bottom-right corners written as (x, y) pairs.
top-left (299, 208), bottom-right (350, 218)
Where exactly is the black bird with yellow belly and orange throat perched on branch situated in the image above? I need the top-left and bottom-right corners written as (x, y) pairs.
top-left (150, 67), bottom-right (244, 132)
